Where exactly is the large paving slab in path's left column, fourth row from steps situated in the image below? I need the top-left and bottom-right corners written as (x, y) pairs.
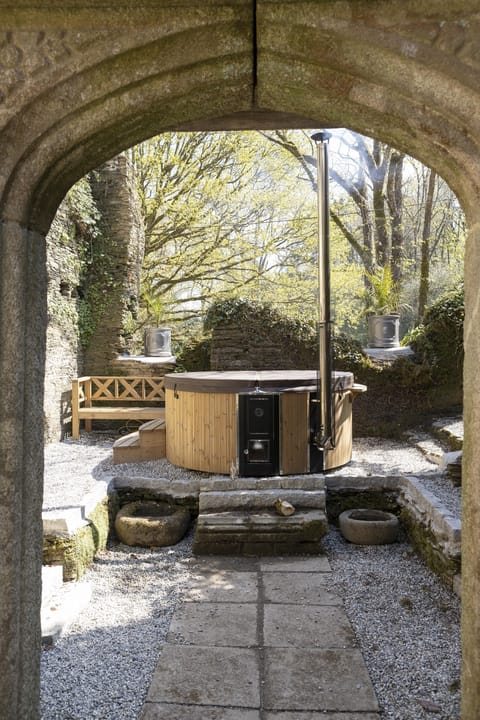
top-left (147, 645), bottom-right (260, 709)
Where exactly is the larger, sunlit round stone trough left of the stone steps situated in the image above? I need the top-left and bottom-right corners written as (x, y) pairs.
top-left (115, 500), bottom-right (190, 547)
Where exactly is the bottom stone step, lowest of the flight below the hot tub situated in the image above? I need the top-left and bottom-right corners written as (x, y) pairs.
top-left (193, 509), bottom-right (328, 556)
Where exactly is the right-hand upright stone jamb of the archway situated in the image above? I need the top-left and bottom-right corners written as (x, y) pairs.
top-left (462, 213), bottom-right (480, 720)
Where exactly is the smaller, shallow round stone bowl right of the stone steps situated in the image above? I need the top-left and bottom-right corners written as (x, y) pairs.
top-left (338, 508), bottom-right (399, 545)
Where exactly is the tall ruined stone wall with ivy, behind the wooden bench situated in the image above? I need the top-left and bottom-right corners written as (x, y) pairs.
top-left (44, 154), bottom-right (144, 442)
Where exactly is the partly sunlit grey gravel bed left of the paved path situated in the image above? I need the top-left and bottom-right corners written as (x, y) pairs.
top-left (41, 536), bottom-right (195, 720)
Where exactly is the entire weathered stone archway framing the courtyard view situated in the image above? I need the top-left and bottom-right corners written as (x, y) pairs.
top-left (0, 0), bottom-right (480, 720)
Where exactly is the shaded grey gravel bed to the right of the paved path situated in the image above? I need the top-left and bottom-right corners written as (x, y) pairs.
top-left (324, 528), bottom-right (461, 720)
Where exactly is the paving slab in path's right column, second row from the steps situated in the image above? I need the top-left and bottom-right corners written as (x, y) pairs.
top-left (263, 572), bottom-right (342, 605)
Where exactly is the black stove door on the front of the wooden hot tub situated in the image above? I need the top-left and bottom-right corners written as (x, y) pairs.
top-left (238, 393), bottom-right (280, 477)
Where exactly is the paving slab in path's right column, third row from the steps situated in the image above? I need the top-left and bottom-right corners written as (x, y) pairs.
top-left (264, 604), bottom-right (355, 648)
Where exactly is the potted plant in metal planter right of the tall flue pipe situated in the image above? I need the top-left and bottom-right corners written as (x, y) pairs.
top-left (367, 265), bottom-right (404, 348)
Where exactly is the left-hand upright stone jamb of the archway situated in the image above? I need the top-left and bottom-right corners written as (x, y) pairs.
top-left (0, 222), bottom-right (47, 720)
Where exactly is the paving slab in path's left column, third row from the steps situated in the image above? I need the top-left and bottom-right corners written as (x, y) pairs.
top-left (167, 602), bottom-right (257, 647)
